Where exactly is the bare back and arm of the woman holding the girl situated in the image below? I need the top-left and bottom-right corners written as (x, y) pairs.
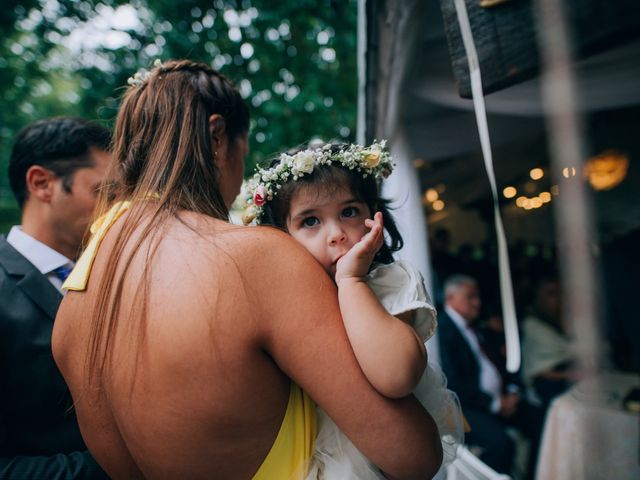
top-left (53, 214), bottom-right (440, 479)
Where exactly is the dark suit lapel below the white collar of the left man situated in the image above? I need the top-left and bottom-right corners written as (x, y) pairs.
top-left (0, 236), bottom-right (62, 320)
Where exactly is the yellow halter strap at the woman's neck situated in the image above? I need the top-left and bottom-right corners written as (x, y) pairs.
top-left (62, 200), bottom-right (131, 292)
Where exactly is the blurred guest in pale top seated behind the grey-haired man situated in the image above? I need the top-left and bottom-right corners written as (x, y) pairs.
top-left (522, 277), bottom-right (576, 407)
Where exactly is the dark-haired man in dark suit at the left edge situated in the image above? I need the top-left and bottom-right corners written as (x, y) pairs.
top-left (0, 117), bottom-right (110, 480)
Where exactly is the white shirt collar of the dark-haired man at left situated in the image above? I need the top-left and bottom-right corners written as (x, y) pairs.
top-left (7, 226), bottom-right (74, 293)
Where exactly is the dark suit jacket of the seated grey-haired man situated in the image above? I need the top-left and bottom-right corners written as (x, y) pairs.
top-left (438, 309), bottom-right (493, 412)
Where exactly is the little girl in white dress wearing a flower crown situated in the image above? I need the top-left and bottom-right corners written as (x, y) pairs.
top-left (243, 141), bottom-right (463, 480)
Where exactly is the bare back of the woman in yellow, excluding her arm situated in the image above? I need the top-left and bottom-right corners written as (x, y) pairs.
top-left (54, 216), bottom-right (289, 478)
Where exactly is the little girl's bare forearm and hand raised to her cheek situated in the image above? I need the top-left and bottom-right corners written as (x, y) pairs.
top-left (335, 213), bottom-right (427, 398)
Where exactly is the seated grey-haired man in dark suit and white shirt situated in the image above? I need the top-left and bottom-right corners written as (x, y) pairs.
top-left (438, 275), bottom-right (544, 478)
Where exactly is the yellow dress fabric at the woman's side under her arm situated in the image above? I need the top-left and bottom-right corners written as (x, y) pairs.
top-left (253, 383), bottom-right (317, 480)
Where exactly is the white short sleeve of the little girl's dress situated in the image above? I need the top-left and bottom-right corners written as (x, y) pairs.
top-left (366, 260), bottom-right (438, 342)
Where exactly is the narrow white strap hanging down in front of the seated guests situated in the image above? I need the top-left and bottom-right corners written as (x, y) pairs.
top-left (454, 0), bottom-right (520, 372)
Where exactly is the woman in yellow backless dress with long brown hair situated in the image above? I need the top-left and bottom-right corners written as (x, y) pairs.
top-left (53, 61), bottom-right (441, 479)
